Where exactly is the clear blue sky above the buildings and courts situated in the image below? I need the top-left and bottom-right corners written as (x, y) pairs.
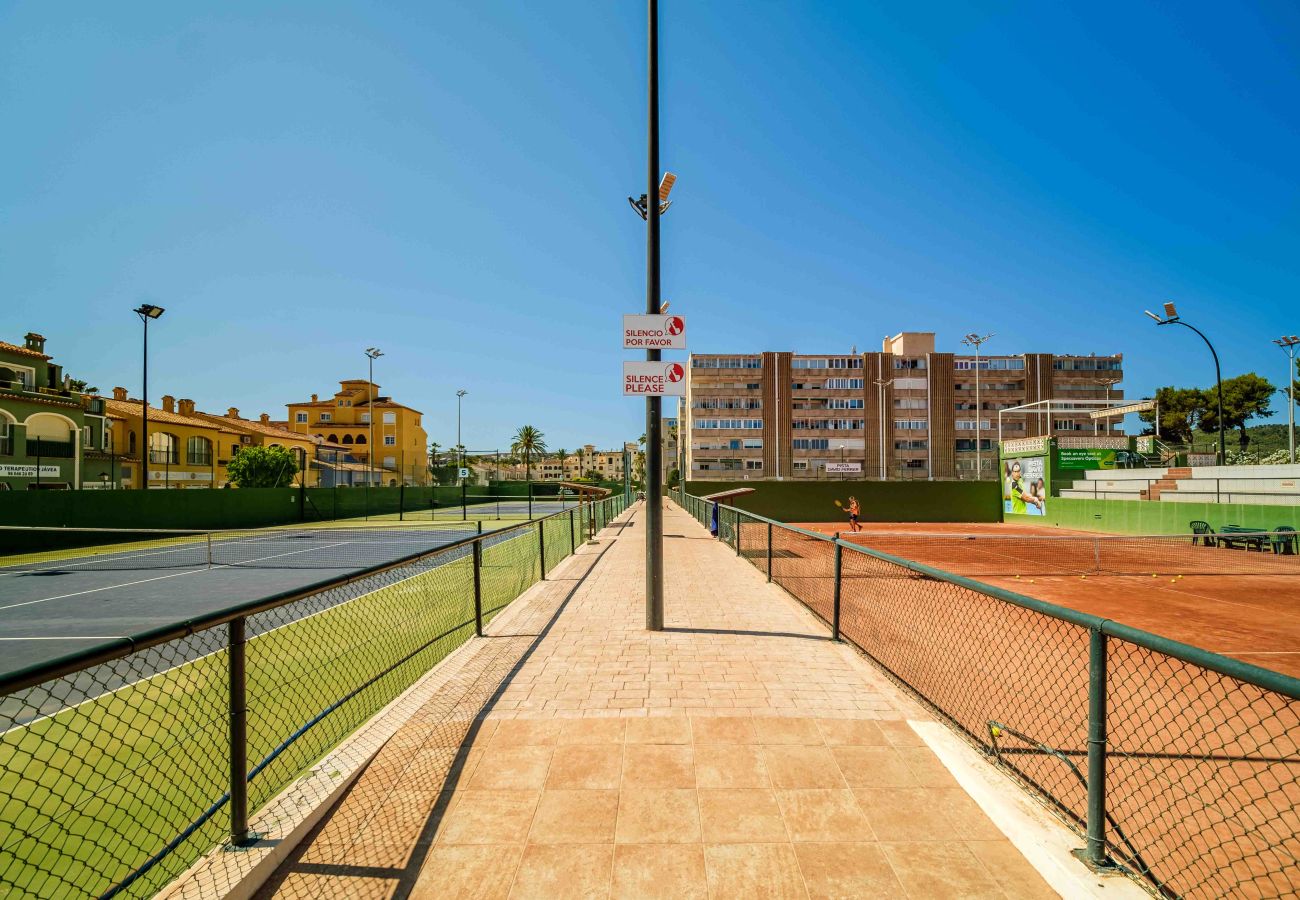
top-left (0, 0), bottom-right (1300, 447)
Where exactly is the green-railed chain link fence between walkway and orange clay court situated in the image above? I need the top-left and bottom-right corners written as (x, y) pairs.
top-left (676, 494), bottom-right (1300, 897)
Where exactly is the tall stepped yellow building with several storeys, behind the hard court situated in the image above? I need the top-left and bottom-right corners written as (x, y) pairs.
top-left (286, 378), bottom-right (429, 484)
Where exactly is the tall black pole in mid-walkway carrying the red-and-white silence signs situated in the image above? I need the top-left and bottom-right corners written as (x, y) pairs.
top-left (646, 0), bottom-right (663, 631)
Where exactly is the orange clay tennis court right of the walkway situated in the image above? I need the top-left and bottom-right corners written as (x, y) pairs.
top-left (738, 512), bottom-right (1300, 897)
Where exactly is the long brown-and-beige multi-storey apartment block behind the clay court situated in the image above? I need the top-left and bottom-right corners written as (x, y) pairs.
top-left (681, 332), bottom-right (1123, 480)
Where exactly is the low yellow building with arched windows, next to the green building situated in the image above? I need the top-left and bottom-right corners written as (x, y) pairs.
top-left (104, 388), bottom-right (241, 488)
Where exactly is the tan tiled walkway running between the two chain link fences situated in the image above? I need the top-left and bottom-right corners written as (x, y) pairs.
top-left (248, 505), bottom-right (1071, 899)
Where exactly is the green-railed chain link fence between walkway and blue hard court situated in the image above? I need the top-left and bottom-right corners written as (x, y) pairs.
top-left (0, 496), bottom-right (627, 897)
